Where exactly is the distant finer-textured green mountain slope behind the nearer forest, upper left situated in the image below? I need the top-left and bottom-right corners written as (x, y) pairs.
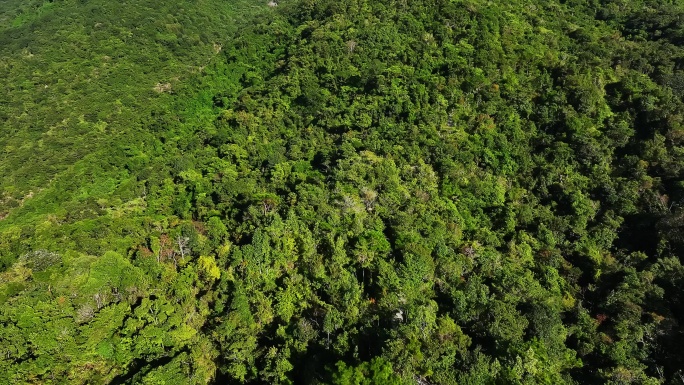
top-left (0, 0), bottom-right (258, 225)
